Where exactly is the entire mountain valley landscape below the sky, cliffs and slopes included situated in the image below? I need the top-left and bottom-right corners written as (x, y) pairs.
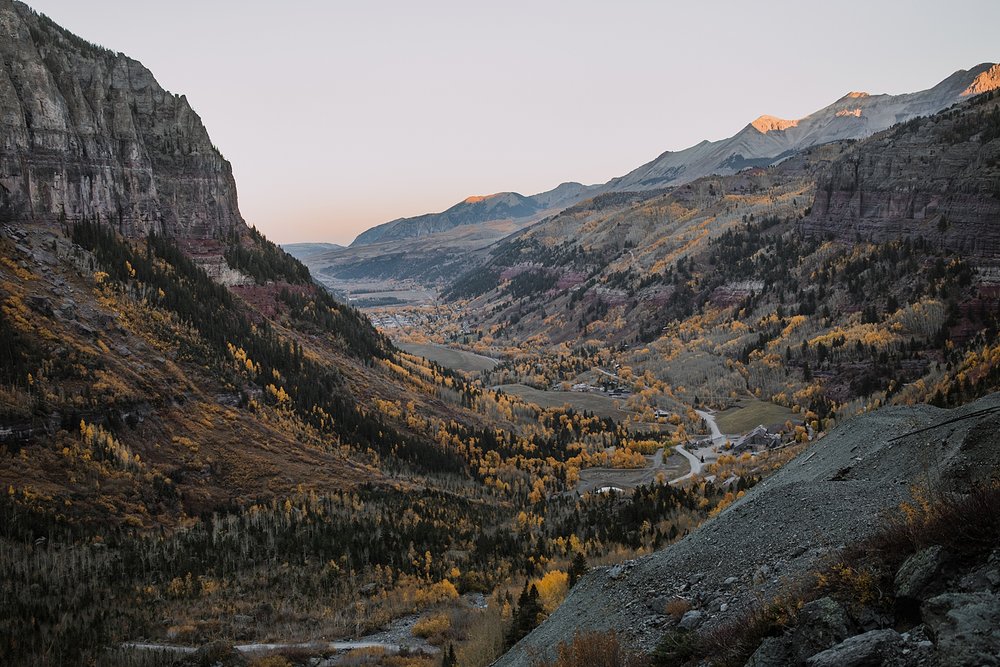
top-left (0, 0), bottom-right (1000, 667)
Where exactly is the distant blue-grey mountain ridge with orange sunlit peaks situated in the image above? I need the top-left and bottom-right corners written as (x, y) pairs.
top-left (342, 63), bottom-right (1000, 252)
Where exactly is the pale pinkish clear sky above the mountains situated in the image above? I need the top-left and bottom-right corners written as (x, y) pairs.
top-left (21, 0), bottom-right (1000, 243)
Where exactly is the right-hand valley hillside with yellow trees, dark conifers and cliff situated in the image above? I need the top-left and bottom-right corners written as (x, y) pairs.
top-left (434, 93), bottom-right (1000, 434)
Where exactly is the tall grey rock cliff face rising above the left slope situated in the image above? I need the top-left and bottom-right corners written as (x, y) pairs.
top-left (0, 0), bottom-right (244, 239)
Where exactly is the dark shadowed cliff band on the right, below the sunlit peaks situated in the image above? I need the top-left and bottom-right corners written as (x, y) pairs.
top-left (802, 92), bottom-right (1000, 260)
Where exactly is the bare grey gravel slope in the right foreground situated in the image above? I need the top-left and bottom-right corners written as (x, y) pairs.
top-left (495, 394), bottom-right (1000, 667)
